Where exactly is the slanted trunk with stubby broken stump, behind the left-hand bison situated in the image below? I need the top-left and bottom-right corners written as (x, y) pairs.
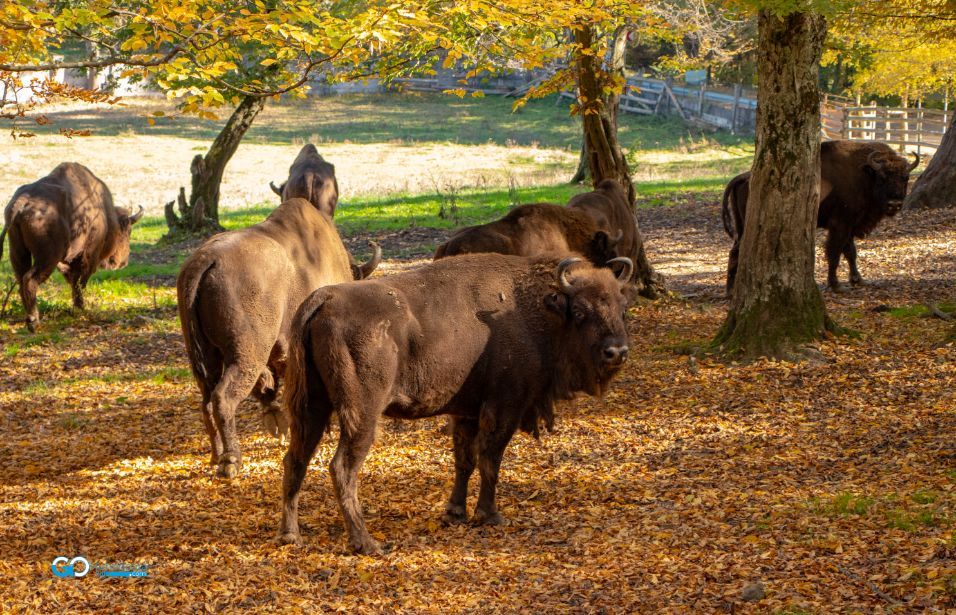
top-left (166, 96), bottom-right (265, 233)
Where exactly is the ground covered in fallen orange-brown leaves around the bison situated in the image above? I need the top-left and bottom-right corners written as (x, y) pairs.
top-left (0, 197), bottom-right (956, 613)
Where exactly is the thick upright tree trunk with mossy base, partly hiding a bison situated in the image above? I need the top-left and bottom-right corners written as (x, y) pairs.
top-left (715, 9), bottom-right (829, 359)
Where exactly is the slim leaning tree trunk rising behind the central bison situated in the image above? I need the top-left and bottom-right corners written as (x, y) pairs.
top-left (574, 26), bottom-right (664, 298)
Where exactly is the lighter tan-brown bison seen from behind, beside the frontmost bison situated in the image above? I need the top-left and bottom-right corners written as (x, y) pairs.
top-left (176, 199), bottom-right (381, 478)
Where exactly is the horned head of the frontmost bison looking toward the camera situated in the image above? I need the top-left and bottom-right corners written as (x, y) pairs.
top-left (545, 256), bottom-right (634, 395)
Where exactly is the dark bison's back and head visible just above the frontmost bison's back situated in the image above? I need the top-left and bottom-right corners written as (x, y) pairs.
top-left (435, 203), bottom-right (622, 266)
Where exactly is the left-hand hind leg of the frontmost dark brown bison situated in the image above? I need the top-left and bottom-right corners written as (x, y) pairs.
top-left (276, 408), bottom-right (328, 545)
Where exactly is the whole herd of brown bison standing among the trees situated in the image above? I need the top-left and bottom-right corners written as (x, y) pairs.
top-left (0, 141), bottom-right (918, 553)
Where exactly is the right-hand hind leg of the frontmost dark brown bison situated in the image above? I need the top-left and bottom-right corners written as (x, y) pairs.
top-left (329, 408), bottom-right (382, 555)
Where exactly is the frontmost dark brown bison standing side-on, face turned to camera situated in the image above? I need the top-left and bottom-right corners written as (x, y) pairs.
top-left (278, 254), bottom-right (633, 553)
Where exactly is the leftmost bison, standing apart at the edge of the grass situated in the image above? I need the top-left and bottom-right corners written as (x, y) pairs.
top-left (0, 162), bottom-right (143, 331)
